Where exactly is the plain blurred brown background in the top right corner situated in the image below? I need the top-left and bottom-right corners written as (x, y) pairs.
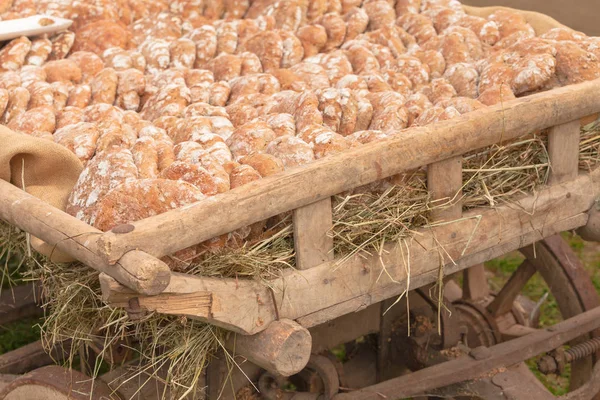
top-left (461, 0), bottom-right (600, 36)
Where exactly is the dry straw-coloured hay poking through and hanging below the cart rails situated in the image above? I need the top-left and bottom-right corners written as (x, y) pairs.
top-left (7, 124), bottom-right (600, 398)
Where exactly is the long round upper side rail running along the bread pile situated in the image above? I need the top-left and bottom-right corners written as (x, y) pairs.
top-left (98, 80), bottom-right (600, 263)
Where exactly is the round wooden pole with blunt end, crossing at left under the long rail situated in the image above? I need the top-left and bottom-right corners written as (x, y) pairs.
top-left (0, 180), bottom-right (171, 295)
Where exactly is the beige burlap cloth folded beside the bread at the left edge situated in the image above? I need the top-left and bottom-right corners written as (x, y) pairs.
top-left (0, 126), bottom-right (83, 262)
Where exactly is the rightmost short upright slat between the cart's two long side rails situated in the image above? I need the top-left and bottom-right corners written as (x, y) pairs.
top-left (548, 120), bottom-right (581, 184)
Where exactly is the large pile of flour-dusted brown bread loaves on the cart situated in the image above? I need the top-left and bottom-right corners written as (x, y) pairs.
top-left (0, 0), bottom-right (600, 268)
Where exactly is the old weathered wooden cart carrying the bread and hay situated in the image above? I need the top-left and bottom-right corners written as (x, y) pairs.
top-left (0, 76), bottom-right (600, 400)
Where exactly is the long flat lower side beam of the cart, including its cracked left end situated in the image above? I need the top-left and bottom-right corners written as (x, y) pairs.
top-left (103, 170), bottom-right (600, 333)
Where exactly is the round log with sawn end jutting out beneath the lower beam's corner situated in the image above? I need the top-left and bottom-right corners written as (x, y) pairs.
top-left (225, 319), bottom-right (312, 376)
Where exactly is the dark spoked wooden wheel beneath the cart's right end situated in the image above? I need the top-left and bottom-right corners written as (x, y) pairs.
top-left (452, 235), bottom-right (600, 390)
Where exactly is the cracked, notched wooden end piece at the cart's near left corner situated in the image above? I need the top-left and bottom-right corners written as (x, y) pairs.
top-left (100, 273), bottom-right (278, 335)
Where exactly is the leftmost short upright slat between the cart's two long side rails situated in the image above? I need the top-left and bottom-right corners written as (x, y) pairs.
top-left (293, 197), bottom-right (333, 269)
